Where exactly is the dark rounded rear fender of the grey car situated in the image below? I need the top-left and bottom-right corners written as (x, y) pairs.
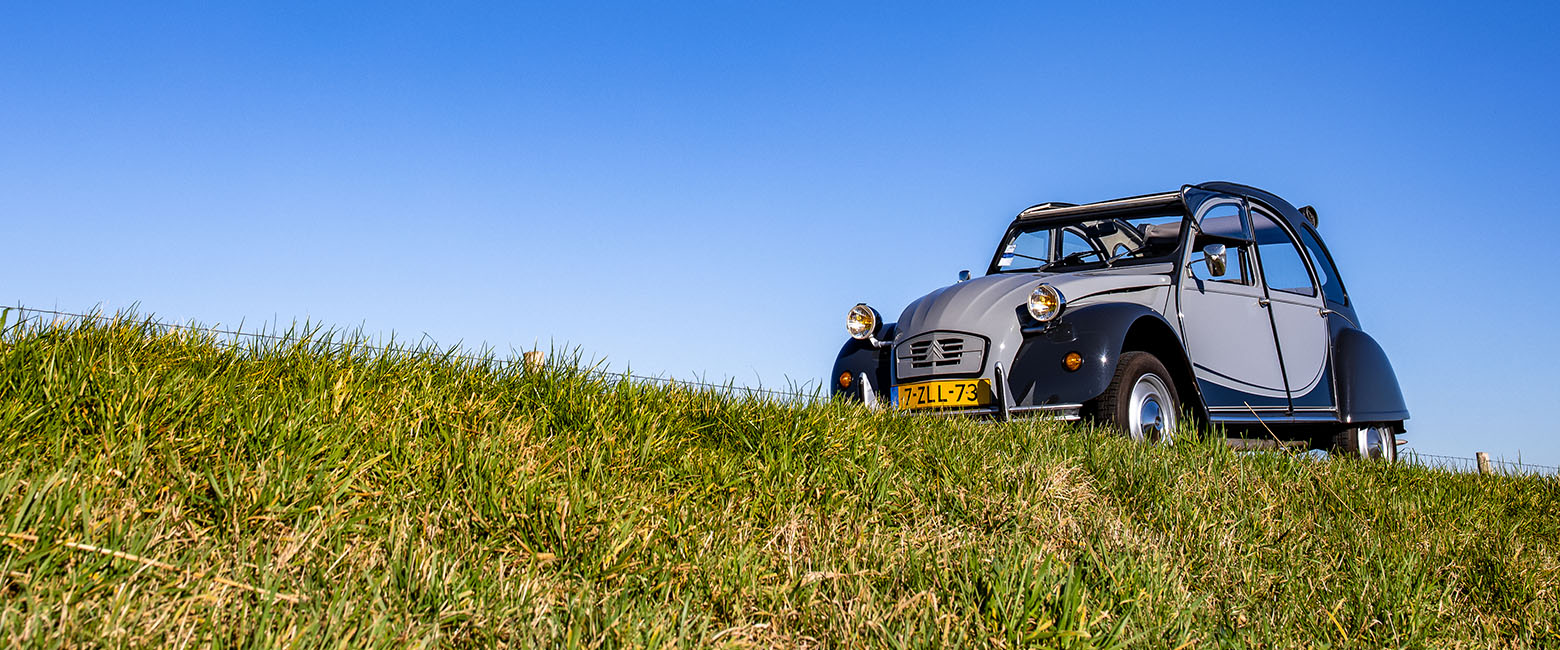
top-left (1332, 327), bottom-right (1409, 422)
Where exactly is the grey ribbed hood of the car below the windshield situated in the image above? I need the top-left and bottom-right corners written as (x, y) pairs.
top-left (895, 265), bottom-right (1170, 338)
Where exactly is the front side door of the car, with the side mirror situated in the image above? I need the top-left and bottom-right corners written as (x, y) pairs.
top-left (1178, 196), bottom-right (1289, 416)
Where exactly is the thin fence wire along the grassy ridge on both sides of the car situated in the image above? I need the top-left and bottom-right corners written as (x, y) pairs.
top-left (0, 300), bottom-right (1560, 475)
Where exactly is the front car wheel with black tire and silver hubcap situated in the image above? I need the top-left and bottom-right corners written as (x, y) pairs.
top-left (1094, 352), bottom-right (1181, 443)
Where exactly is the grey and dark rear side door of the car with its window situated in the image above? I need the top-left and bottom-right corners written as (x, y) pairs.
top-left (1251, 207), bottom-right (1335, 419)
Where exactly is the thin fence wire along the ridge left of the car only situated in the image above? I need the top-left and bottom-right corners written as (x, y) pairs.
top-left (0, 306), bottom-right (824, 401)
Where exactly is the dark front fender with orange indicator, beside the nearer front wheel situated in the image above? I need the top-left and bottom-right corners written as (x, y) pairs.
top-left (1008, 302), bottom-right (1168, 405)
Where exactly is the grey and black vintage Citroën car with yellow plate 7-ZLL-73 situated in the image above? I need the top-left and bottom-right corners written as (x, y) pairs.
top-left (830, 182), bottom-right (1409, 460)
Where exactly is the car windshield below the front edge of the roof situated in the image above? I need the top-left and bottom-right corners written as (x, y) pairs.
top-left (994, 214), bottom-right (1182, 273)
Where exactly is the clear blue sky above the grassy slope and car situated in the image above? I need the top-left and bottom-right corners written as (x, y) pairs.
top-left (0, 2), bottom-right (1560, 465)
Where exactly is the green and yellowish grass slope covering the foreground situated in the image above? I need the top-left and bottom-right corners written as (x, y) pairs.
top-left (0, 311), bottom-right (1560, 648)
